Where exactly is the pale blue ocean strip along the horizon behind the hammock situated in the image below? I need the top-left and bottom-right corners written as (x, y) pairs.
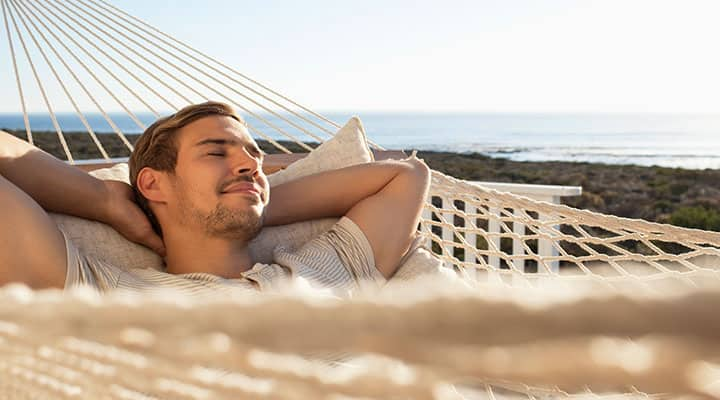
top-left (0, 112), bottom-right (720, 169)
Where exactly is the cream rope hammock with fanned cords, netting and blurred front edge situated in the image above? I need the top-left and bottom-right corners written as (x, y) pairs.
top-left (0, 0), bottom-right (720, 399)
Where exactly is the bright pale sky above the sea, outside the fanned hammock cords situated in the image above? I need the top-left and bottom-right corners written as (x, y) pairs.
top-left (0, 0), bottom-right (720, 113)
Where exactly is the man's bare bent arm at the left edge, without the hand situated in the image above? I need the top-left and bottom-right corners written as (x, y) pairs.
top-left (0, 131), bottom-right (159, 288)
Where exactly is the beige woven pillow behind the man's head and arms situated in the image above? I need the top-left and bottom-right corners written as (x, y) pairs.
top-left (50, 117), bottom-right (373, 271)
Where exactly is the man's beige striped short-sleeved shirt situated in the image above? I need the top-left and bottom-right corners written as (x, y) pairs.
top-left (60, 217), bottom-right (385, 297)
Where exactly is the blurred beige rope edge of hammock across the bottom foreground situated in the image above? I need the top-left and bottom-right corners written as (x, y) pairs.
top-left (0, 287), bottom-right (720, 398)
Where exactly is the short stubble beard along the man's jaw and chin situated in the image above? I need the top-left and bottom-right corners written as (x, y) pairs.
top-left (175, 177), bottom-right (265, 242)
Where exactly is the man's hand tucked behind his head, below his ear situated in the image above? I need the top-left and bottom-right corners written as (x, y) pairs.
top-left (103, 180), bottom-right (165, 257)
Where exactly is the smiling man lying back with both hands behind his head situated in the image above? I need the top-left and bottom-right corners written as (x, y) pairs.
top-left (0, 102), bottom-right (429, 293)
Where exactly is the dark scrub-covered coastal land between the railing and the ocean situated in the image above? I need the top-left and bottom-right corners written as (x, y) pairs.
top-left (6, 130), bottom-right (720, 231)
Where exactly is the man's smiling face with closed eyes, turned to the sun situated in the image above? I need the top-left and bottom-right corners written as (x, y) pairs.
top-left (168, 115), bottom-right (270, 241)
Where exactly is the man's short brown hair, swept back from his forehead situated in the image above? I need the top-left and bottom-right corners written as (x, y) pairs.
top-left (128, 101), bottom-right (247, 234)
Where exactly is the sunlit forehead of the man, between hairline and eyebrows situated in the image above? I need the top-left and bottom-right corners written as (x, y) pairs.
top-left (177, 115), bottom-right (255, 150)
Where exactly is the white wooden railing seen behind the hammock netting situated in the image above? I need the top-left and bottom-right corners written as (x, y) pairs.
top-left (423, 181), bottom-right (582, 273)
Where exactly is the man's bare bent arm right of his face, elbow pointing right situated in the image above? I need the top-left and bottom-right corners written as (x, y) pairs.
top-left (265, 158), bottom-right (430, 278)
